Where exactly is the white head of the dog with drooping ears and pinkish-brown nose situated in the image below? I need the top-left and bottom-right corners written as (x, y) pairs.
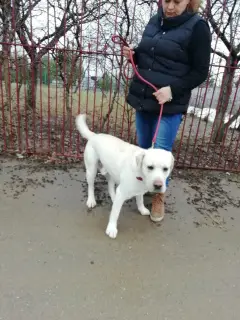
top-left (135, 149), bottom-right (174, 193)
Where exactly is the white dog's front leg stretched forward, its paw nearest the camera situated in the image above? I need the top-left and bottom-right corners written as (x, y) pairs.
top-left (106, 186), bottom-right (126, 239)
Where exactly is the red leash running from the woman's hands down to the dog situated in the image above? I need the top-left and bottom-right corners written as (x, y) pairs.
top-left (112, 35), bottom-right (163, 148)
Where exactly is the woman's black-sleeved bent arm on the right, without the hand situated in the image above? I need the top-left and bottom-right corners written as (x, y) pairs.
top-left (170, 20), bottom-right (212, 97)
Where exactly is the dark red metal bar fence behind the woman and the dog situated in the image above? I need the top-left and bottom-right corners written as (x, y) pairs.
top-left (0, 0), bottom-right (240, 171)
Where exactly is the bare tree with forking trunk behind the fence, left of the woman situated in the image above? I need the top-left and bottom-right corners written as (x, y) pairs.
top-left (13, 0), bottom-right (115, 109)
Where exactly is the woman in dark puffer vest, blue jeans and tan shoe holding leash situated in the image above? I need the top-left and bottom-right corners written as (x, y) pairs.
top-left (123, 0), bottom-right (211, 222)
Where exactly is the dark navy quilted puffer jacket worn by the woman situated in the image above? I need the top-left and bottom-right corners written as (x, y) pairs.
top-left (127, 7), bottom-right (211, 114)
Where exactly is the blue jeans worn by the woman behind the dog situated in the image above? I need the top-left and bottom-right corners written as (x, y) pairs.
top-left (136, 111), bottom-right (182, 186)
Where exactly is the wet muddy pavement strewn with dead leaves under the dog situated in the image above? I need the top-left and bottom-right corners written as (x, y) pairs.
top-left (0, 158), bottom-right (240, 320)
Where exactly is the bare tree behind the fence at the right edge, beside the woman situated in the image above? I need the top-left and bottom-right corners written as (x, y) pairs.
top-left (205, 0), bottom-right (240, 142)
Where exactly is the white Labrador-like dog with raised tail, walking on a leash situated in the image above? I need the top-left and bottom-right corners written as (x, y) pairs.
top-left (76, 114), bottom-right (174, 238)
